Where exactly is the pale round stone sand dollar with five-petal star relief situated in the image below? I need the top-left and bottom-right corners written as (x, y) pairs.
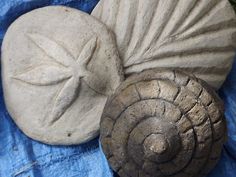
top-left (1, 6), bottom-right (122, 145)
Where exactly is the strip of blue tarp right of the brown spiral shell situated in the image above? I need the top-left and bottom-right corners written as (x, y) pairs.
top-left (209, 60), bottom-right (236, 177)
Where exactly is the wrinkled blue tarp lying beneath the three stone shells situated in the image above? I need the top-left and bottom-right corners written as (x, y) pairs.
top-left (0, 0), bottom-right (236, 177)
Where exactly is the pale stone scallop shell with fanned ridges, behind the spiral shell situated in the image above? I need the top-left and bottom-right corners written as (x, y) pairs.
top-left (92, 0), bottom-right (236, 89)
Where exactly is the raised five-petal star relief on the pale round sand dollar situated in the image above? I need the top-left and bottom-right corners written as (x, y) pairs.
top-left (14, 34), bottom-right (99, 125)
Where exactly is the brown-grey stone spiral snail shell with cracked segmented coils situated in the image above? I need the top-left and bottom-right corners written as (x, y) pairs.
top-left (100, 69), bottom-right (226, 177)
